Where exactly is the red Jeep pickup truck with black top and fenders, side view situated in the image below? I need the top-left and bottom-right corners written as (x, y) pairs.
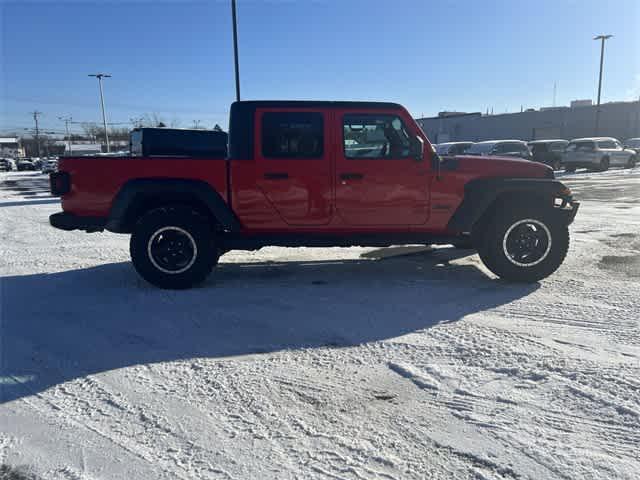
top-left (50, 101), bottom-right (578, 288)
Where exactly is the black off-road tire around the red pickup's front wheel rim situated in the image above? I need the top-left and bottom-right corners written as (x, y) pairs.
top-left (477, 207), bottom-right (569, 283)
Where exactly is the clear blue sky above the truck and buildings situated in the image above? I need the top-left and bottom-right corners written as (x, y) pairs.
top-left (0, 0), bottom-right (640, 135)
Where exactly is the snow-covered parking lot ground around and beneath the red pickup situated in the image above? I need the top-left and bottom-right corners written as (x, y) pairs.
top-left (0, 168), bottom-right (640, 480)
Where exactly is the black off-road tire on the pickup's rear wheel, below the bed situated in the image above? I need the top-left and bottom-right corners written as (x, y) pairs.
top-left (129, 206), bottom-right (218, 289)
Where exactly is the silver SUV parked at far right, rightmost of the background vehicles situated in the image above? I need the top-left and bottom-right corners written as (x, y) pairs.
top-left (562, 137), bottom-right (637, 172)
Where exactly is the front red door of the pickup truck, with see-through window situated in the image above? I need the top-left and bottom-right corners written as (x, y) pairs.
top-left (334, 110), bottom-right (429, 226)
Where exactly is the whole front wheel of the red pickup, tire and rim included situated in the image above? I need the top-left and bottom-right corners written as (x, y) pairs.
top-left (478, 209), bottom-right (569, 282)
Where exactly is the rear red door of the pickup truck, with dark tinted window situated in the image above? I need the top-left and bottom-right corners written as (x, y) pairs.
top-left (254, 109), bottom-right (332, 225)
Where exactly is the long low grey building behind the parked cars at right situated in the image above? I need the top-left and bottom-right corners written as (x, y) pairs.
top-left (417, 100), bottom-right (640, 143)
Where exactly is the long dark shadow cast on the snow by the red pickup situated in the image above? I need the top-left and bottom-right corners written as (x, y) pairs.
top-left (0, 249), bottom-right (538, 402)
